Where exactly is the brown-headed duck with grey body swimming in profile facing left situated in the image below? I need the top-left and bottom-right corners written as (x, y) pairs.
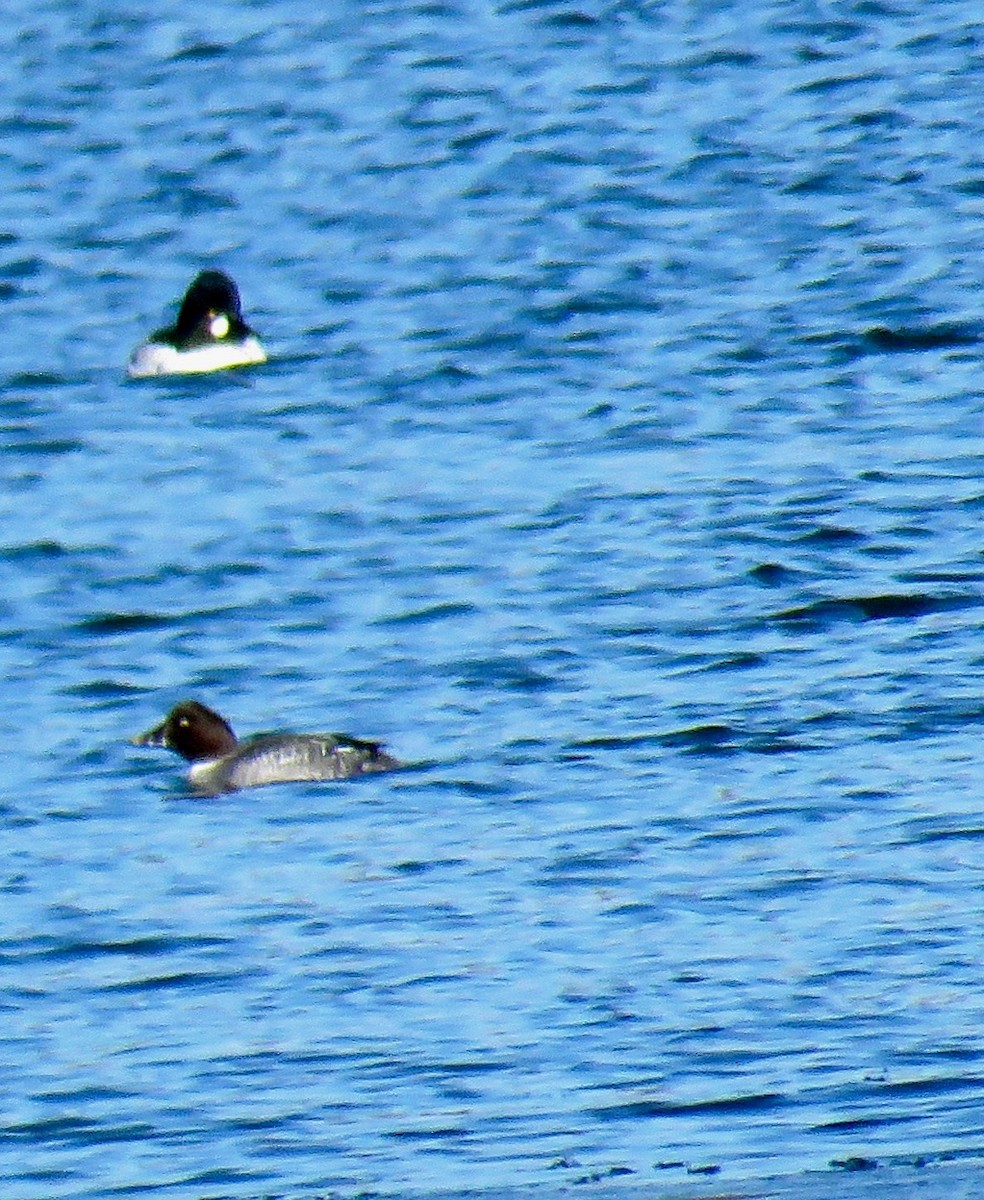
top-left (132, 700), bottom-right (404, 796)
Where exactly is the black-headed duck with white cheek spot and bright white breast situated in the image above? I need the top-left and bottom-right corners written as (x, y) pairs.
top-left (126, 270), bottom-right (266, 379)
